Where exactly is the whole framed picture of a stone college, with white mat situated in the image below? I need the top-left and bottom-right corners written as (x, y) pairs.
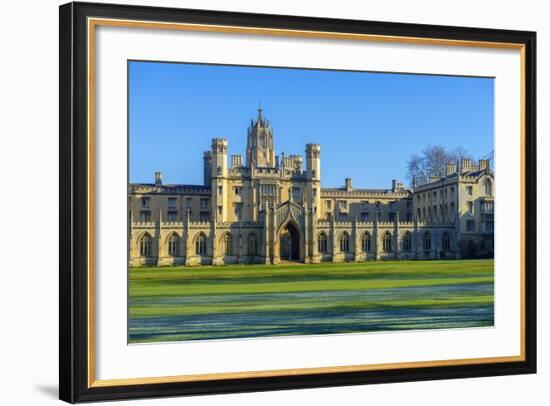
top-left (60, 3), bottom-right (536, 402)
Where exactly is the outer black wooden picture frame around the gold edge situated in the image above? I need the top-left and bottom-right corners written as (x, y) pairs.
top-left (59, 3), bottom-right (537, 403)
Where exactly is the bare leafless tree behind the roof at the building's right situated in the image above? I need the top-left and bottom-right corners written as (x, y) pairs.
top-left (407, 145), bottom-right (472, 183)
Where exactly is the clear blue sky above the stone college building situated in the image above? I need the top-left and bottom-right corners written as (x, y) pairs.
top-left (129, 62), bottom-right (494, 188)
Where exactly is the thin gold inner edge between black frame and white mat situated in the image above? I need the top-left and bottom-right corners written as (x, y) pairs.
top-left (87, 18), bottom-right (526, 388)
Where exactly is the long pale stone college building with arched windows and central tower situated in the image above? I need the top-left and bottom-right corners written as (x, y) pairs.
top-left (128, 108), bottom-right (494, 266)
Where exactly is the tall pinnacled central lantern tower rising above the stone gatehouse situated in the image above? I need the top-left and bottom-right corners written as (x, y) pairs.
top-left (246, 105), bottom-right (275, 168)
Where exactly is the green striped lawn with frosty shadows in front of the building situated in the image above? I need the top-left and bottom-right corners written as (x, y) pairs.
top-left (129, 260), bottom-right (494, 342)
